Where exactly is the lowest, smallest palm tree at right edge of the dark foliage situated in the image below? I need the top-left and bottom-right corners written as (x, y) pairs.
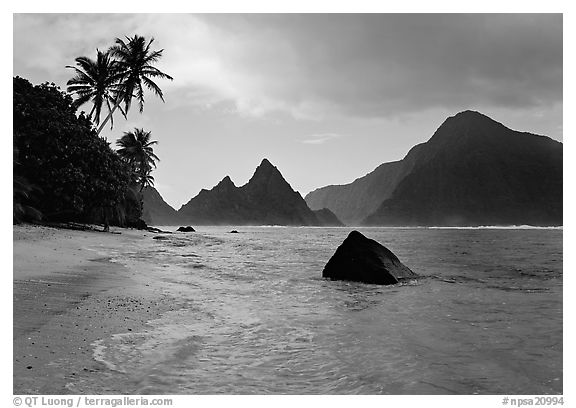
top-left (116, 128), bottom-right (160, 192)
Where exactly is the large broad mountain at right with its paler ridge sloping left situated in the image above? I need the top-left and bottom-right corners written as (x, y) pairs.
top-left (306, 111), bottom-right (563, 226)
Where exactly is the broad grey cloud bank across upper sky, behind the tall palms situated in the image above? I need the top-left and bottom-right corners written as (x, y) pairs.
top-left (14, 14), bottom-right (562, 120)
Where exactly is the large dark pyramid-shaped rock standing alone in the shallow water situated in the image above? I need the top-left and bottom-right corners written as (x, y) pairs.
top-left (322, 231), bottom-right (418, 285)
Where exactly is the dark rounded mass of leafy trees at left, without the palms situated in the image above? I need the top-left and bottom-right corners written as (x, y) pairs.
top-left (13, 77), bottom-right (140, 224)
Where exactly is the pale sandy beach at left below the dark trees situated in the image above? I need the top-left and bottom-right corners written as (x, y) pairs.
top-left (13, 225), bottom-right (172, 394)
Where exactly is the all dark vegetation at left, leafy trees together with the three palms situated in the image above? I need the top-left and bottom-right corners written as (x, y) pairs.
top-left (13, 35), bottom-right (172, 228)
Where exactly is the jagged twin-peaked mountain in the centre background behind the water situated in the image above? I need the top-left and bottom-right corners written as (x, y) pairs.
top-left (178, 159), bottom-right (342, 225)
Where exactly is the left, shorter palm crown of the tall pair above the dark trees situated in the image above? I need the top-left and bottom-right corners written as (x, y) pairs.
top-left (66, 49), bottom-right (126, 129)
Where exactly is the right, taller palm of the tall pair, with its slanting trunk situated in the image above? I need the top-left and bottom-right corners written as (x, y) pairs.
top-left (98, 35), bottom-right (173, 134)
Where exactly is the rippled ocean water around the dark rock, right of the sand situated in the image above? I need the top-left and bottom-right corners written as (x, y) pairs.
top-left (87, 227), bottom-right (563, 394)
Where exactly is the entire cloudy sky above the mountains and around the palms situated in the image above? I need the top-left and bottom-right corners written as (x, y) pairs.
top-left (13, 14), bottom-right (563, 209)
